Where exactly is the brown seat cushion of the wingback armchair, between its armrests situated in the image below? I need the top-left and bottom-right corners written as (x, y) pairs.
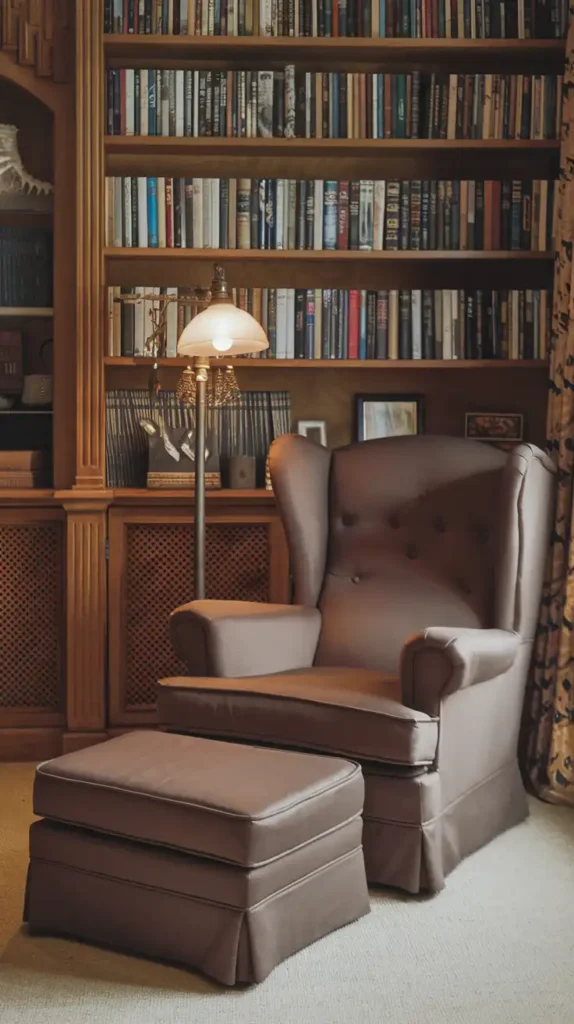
top-left (158, 667), bottom-right (438, 765)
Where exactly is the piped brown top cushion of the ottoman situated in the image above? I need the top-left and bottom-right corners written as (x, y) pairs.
top-left (34, 731), bottom-right (364, 867)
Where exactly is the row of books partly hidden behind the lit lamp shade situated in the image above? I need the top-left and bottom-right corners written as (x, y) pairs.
top-left (108, 288), bottom-right (551, 359)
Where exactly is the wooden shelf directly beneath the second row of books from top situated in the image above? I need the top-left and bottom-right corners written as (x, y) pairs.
top-left (104, 135), bottom-right (560, 180)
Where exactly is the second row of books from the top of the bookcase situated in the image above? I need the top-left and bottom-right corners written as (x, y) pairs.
top-left (106, 65), bottom-right (562, 139)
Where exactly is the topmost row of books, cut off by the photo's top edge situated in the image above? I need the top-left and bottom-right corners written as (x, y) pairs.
top-left (104, 0), bottom-right (568, 39)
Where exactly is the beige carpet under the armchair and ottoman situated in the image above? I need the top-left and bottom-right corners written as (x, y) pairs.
top-left (0, 765), bottom-right (574, 1024)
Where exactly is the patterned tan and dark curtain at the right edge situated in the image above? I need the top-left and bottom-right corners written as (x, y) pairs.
top-left (523, 16), bottom-right (574, 805)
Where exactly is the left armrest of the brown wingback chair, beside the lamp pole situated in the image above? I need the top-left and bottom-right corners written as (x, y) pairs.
top-left (170, 601), bottom-right (321, 678)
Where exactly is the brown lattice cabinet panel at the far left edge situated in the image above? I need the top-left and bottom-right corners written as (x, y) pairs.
top-left (0, 511), bottom-right (64, 724)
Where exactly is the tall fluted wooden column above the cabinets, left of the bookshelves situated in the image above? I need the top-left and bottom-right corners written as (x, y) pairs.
top-left (75, 0), bottom-right (104, 489)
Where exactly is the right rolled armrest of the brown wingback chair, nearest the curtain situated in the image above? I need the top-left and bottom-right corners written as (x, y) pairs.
top-left (401, 626), bottom-right (520, 715)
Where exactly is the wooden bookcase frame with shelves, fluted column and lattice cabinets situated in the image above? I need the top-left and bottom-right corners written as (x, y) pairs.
top-left (0, 0), bottom-right (565, 759)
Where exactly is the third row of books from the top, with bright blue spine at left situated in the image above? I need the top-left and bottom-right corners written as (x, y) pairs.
top-left (105, 177), bottom-right (555, 252)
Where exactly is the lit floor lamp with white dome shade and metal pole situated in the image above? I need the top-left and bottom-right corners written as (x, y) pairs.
top-left (177, 265), bottom-right (269, 600)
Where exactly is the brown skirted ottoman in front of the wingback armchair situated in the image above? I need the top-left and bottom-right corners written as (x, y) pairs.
top-left (25, 732), bottom-right (368, 985)
